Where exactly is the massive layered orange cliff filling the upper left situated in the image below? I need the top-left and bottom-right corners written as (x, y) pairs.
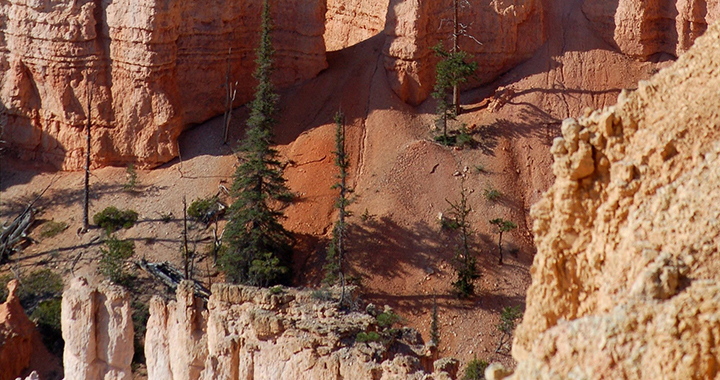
top-left (0, 0), bottom-right (327, 169)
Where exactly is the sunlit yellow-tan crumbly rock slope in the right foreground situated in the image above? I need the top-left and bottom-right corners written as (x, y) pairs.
top-left (512, 20), bottom-right (720, 379)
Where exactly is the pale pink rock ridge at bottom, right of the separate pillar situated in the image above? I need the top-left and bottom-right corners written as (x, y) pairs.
top-left (145, 283), bottom-right (457, 380)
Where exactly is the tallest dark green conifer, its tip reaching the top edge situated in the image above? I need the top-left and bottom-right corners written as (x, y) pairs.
top-left (218, 0), bottom-right (292, 286)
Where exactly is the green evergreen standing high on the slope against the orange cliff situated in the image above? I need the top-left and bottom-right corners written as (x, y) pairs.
top-left (431, 43), bottom-right (477, 145)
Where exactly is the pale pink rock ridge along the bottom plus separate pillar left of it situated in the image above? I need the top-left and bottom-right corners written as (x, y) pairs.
top-left (62, 278), bottom-right (458, 380)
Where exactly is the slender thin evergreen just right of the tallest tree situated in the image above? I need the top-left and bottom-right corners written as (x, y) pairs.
top-left (325, 112), bottom-right (350, 306)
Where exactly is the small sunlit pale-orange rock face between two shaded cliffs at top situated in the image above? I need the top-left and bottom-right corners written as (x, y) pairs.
top-left (325, 0), bottom-right (389, 51)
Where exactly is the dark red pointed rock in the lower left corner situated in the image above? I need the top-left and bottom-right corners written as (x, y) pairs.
top-left (0, 280), bottom-right (37, 380)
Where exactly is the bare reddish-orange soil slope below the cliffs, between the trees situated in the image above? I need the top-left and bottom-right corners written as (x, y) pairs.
top-left (0, 1), bottom-right (653, 374)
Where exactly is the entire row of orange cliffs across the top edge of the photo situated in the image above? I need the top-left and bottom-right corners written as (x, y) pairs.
top-left (0, 0), bottom-right (720, 170)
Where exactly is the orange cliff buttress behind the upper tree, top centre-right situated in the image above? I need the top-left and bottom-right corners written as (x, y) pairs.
top-left (383, 0), bottom-right (545, 104)
